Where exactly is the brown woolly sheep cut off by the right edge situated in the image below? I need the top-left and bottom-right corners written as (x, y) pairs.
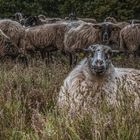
top-left (120, 24), bottom-right (140, 54)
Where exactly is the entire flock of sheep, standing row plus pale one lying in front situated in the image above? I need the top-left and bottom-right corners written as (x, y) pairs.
top-left (0, 13), bottom-right (140, 114)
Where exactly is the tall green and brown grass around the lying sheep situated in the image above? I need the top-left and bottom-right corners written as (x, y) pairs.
top-left (0, 57), bottom-right (140, 140)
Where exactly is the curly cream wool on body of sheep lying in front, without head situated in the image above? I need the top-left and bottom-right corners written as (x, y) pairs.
top-left (58, 59), bottom-right (140, 115)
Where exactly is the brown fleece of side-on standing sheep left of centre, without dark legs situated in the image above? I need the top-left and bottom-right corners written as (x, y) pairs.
top-left (25, 24), bottom-right (66, 48)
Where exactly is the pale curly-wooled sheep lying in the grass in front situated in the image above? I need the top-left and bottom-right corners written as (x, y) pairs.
top-left (57, 44), bottom-right (140, 116)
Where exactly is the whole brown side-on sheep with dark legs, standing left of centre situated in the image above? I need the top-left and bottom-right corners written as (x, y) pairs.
top-left (25, 23), bottom-right (66, 58)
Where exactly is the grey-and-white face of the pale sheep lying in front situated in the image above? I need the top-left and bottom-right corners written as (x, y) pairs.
top-left (88, 44), bottom-right (112, 75)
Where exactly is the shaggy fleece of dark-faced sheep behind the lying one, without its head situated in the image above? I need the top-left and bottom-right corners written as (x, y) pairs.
top-left (64, 22), bottom-right (100, 52)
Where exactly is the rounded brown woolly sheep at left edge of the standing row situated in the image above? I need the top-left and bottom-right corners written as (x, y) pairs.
top-left (0, 19), bottom-right (25, 54)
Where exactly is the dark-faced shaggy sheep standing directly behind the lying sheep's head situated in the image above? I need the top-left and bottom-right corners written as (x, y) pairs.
top-left (64, 22), bottom-right (120, 65)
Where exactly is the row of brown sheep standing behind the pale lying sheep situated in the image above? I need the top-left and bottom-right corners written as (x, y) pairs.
top-left (0, 13), bottom-right (140, 65)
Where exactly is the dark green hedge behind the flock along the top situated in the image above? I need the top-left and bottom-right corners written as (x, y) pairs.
top-left (0, 0), bottom-right (140, 21)
